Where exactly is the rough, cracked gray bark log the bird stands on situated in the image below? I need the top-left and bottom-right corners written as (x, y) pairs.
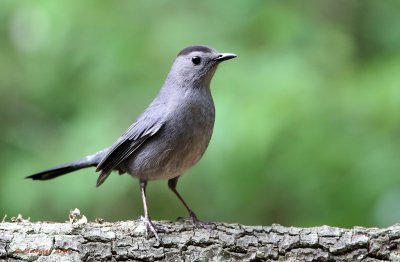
top-left (0, 217), bottom-right (400, 261)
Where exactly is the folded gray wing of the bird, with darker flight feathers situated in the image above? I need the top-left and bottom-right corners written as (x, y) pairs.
top-left (96, 114), bottom-right (163, 186)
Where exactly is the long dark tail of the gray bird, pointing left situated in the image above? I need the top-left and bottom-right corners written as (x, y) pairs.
top-left (25, 150), bottom-right (105, 180)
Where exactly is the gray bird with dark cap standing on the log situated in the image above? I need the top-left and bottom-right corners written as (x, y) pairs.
top-left (27, 46), bottom-right (236, 240)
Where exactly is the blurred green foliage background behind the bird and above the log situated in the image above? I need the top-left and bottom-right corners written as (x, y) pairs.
top-left (0, 0), bottom-right (400, 227)
